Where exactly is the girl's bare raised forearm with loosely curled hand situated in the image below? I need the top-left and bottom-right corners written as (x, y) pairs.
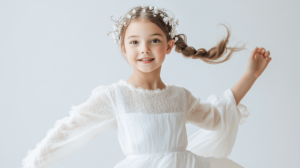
top-left (231, 47), bottom-right (272, 105)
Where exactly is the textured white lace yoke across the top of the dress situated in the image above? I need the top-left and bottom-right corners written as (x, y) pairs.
top-left (99, 79), bottom-right (185, 114)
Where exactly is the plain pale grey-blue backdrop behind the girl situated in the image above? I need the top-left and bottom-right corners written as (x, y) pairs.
top-left (0, 0), bottom-right (300, 168)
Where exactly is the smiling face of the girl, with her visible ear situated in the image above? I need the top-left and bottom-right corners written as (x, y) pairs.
top-left (122, 18), bottom-right (174, 73)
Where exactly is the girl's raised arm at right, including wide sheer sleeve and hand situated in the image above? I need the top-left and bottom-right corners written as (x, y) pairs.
top-left (184, 48), bottom-right (271, 158)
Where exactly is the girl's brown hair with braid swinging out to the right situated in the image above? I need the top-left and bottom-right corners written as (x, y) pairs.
top-left (120, 6), bottom-right (245, 64)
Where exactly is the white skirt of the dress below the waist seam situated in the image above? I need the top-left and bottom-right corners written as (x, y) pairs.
top-left (114, 150), bottom-right (243, 168)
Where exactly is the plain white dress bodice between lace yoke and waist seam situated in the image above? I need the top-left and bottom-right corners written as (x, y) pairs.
top-left (105, 85), bottom-right (188, 155)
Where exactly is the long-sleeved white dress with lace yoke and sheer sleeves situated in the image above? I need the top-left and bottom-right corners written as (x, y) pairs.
top-left (23, 79), bottom-right (249, 168)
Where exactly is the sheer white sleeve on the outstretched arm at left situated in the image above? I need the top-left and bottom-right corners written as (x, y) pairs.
top-left (22, 86), bottom-right (117, 168)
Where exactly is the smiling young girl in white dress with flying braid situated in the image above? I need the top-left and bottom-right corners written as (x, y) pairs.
top-left (23, 6), bottom-right (271, 168)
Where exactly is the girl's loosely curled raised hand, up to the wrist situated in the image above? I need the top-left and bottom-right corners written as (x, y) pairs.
top-left (246, 47), bottom-right (272, 79)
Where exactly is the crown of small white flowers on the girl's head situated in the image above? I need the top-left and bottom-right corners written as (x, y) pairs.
top-left (107, 6), bottom-right (179, 46)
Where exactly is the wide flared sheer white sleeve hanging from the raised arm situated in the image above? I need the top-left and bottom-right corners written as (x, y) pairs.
top-left (185, 89), bottom-right (249, 157)
